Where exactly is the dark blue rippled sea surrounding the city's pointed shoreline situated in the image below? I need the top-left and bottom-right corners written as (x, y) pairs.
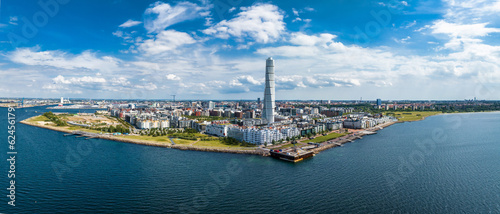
top-left (0, 107), bottom-right (500, 213)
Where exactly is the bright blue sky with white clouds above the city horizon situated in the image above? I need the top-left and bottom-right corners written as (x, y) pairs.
top-left (0, 0), bottom-right (500, 100)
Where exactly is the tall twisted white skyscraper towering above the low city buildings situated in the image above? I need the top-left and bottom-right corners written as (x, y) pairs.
top-left (262, 57), bottom-right (275, 124)
